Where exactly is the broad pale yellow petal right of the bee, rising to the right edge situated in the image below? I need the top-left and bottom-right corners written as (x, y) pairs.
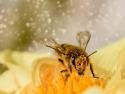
top-left (90, 39), bottom-right (125, 78)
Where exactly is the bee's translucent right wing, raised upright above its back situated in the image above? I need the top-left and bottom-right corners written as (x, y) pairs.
top-left (76, 31), bottom-right (91, 50)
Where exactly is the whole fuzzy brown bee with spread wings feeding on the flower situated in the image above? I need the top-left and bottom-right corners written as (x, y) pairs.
top-left (36, 31), bottom-right (98, 79)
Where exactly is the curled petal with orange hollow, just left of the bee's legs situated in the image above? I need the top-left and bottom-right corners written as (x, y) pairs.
top-left (33, 58), bottom-right (59, 89)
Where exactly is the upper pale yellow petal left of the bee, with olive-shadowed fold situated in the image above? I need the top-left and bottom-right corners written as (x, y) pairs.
top-left (0, 50), bottom-right (50, 71)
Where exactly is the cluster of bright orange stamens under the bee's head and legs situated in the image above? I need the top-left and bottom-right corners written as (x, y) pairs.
top-left (35, 73), bottom-right (104, 94)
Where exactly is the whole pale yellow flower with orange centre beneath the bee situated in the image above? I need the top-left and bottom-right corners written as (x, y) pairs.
top-left (0, 39), bottom-right (125, 94)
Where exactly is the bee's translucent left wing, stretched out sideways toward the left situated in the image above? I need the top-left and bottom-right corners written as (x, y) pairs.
top-left (36, 37), bottom-right (64, 54)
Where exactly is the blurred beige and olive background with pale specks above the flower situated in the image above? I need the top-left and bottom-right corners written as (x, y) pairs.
top-left (0, 0), bottom-right (125, 52)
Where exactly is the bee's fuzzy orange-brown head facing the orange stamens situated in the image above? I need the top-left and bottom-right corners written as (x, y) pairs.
top-left (72, 55), bottom-right (88, 75)
